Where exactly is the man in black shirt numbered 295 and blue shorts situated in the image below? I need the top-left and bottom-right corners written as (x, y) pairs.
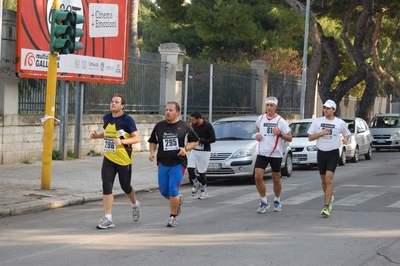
top-left (148, 102), bottom-right (199, 227)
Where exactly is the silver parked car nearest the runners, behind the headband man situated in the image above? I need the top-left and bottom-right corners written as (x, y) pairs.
top-left (206, 116), bottom-right (293, 180)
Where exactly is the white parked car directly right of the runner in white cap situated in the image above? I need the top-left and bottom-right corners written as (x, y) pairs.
top-left (341, 117), bottom-right (372, 163)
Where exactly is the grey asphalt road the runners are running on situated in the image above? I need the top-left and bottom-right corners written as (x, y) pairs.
top-left (0, 151), bottom-right (400, 266)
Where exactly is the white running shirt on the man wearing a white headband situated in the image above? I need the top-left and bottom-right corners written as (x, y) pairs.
top-left (256, 114), bottom-right (290, 158)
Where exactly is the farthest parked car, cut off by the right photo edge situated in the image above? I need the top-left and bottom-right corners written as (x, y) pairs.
top-left (369, 114), bottom-right (400, 151)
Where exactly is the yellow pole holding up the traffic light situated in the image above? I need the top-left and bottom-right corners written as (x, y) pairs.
top-left (41, 0), bottom-right (60, 189)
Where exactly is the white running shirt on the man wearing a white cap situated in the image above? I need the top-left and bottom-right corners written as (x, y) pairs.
top-left (307, 116), bottom-right (351, 151)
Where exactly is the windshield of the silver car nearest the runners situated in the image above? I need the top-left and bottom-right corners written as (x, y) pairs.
top-left (213, 121), bottom-right (256, 140)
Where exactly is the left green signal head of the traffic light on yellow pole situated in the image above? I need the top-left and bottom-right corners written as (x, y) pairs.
top-left (50, 8), bottom-right (73, 54)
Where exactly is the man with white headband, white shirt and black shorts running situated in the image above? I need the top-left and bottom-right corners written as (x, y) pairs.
top-left (254, 96), bottom-right (292, 213)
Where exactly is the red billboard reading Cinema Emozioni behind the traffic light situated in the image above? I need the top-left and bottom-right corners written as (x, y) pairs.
top-left (16, 0), bottom-right (130, 84)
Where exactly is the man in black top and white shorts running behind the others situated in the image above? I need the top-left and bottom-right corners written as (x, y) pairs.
top-left (188, 111), bottom-right (215, 199)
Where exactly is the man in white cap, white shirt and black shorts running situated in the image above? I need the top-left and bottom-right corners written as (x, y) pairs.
top-left (307, 100), bottom-right (351, 217)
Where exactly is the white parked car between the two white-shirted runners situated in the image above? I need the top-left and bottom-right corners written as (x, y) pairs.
top-left (289, 118), bottom-right (346, 166)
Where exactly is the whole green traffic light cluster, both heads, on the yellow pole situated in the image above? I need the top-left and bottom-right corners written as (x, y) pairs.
top-left (50, 8), bottom-right (85, 54)
